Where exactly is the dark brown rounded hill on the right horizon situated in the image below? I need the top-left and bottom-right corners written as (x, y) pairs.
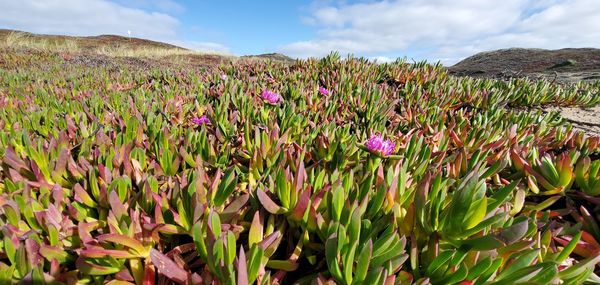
top-left (448, 48), bottom-right (600, 80)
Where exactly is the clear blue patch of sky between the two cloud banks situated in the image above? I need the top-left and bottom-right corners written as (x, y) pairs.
top-left (112, 0), bottom-right (314, 54)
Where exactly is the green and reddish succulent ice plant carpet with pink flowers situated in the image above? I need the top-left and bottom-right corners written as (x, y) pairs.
top-left (0, 51), bottom-right (600, 285)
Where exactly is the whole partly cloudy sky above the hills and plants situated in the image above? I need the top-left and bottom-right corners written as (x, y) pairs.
top-left (0, 0), bottom-right (600, 64)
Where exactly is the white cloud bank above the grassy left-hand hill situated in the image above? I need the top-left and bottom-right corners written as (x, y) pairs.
top-left (0, 0), bottom-right (227, 51)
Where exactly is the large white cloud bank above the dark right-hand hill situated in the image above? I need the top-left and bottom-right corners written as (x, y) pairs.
top-left (280, 0), bottom-right (600, 63)
